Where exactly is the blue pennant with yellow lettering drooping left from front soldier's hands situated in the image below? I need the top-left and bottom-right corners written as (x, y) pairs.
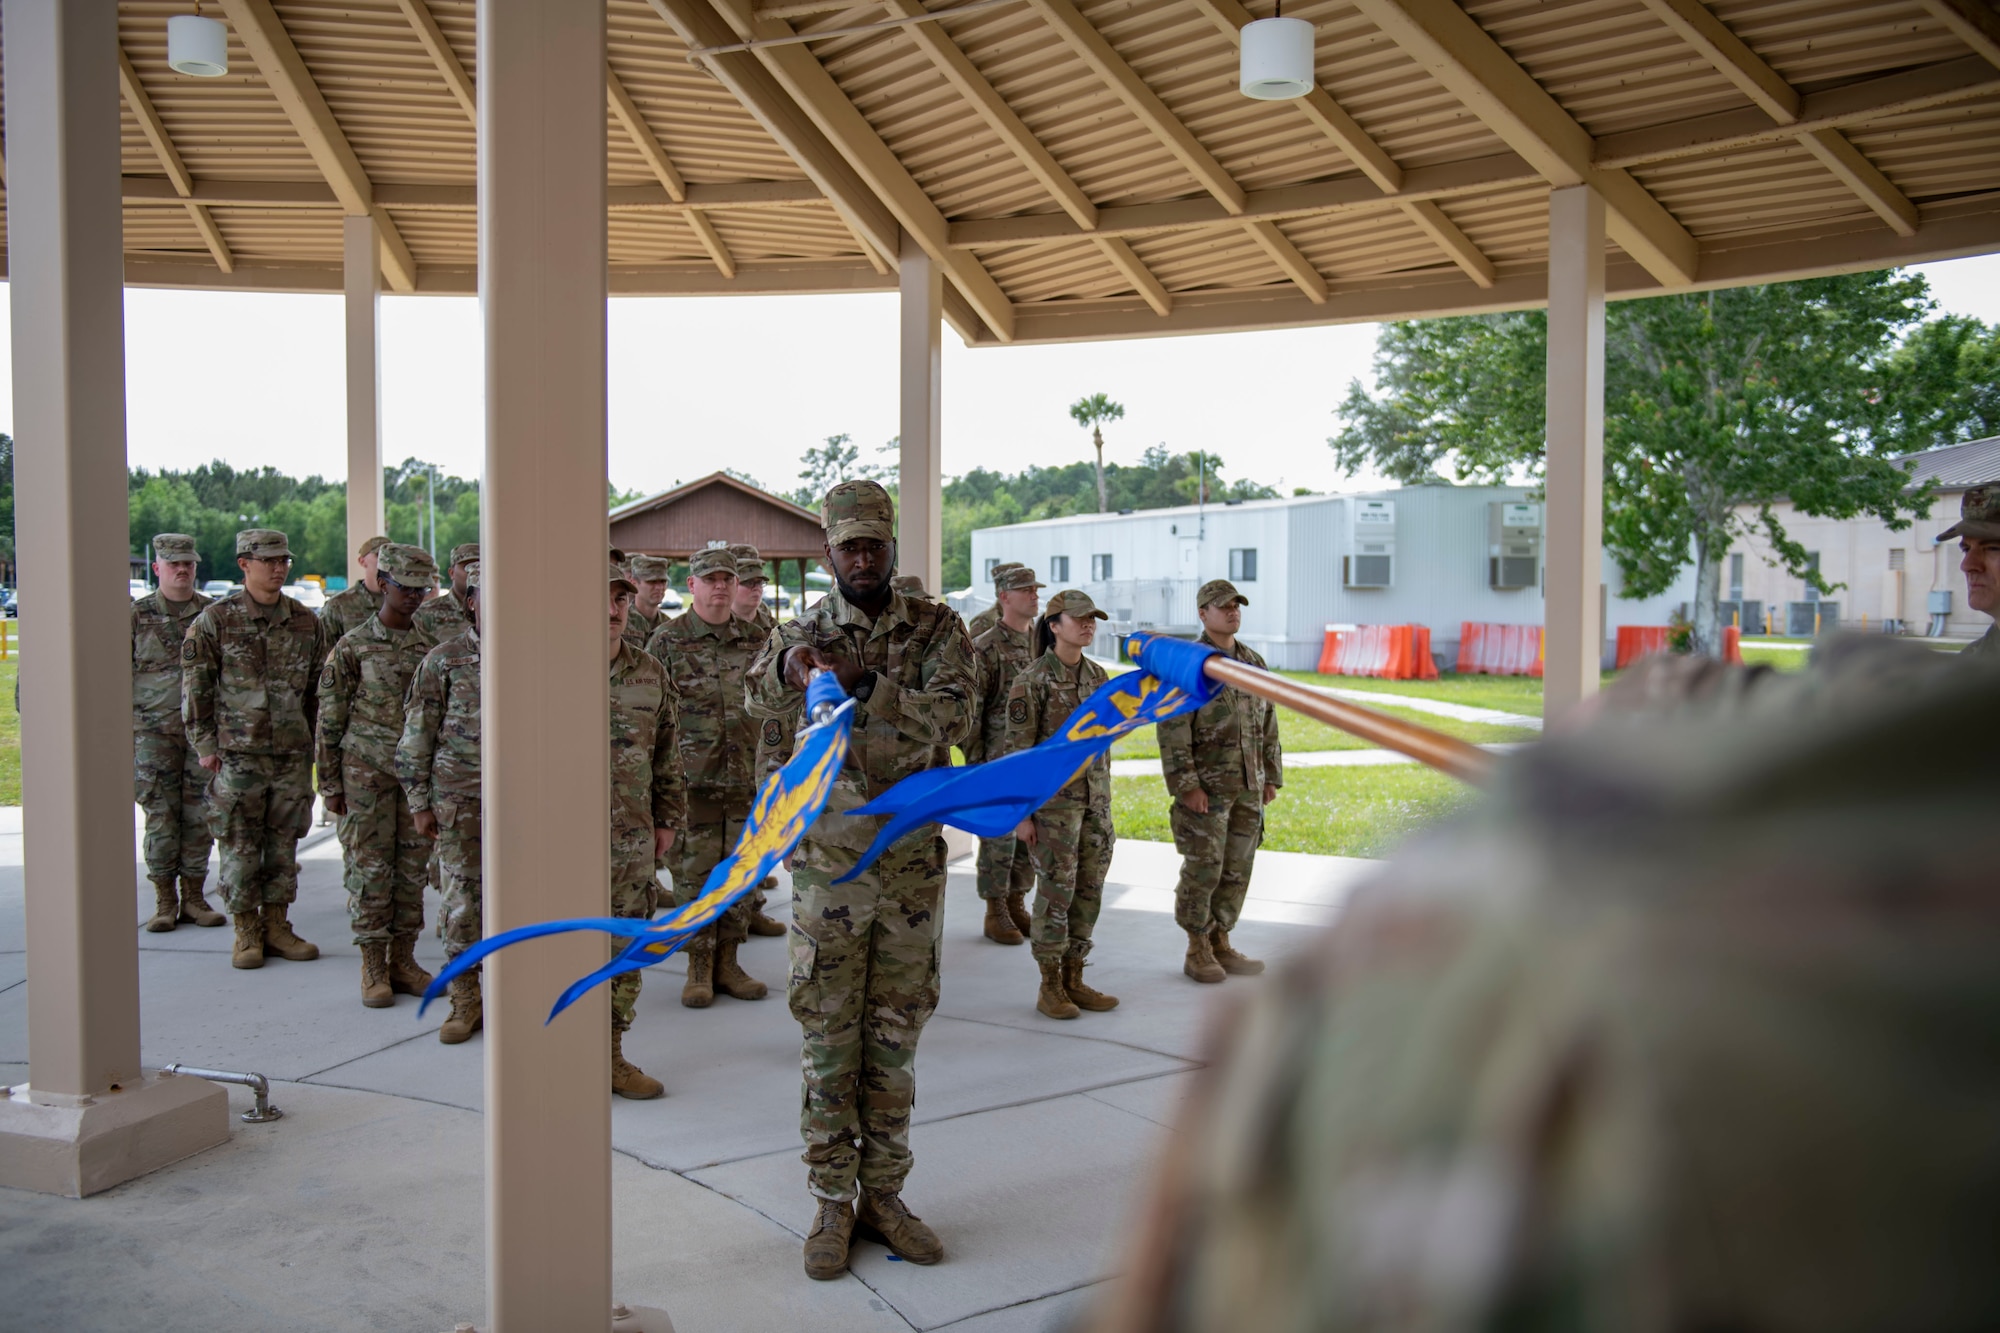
top-left (416, 671), bottom-right (854, 1021)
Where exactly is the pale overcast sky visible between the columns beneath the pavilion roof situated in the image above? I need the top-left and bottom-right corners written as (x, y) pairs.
top-left (0, 256), bottom-right (2000, 490)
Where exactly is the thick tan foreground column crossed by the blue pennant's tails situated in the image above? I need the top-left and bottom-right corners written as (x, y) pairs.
top-left (478, 0), bottom-right (612, 1333)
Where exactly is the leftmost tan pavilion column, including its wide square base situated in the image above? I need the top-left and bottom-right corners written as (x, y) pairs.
top-left (0, 0), bottom-right (230, 1197)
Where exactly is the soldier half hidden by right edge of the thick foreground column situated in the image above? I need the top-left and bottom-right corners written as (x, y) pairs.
top-left (608, 564), bottom-right (688, 1101)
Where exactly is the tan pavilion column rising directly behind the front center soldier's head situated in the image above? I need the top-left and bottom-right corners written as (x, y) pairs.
top-left (896, 232), bottom-right (944, 596)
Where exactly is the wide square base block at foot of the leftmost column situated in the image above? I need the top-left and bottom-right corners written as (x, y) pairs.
top-left (0, 1073), bottom-right (230, 1199)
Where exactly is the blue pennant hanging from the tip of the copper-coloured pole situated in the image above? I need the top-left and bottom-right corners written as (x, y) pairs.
top-left (834, 634), bottom-right (1222, 885)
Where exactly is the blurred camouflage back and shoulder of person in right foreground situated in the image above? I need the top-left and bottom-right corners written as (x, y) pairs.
top-left (1090, 638), bottom-right (2000, 1333)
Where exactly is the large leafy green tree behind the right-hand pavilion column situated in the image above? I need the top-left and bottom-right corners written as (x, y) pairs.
top-left (1328, 272), bottom-right (1930, 650)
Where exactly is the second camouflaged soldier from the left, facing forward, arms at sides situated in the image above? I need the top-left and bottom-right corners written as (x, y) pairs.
top-left (180, 528), bottom-right (332, 967)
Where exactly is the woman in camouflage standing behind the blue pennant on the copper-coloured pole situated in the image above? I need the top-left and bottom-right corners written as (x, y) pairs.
top-left (1006, 588), bottom-right (1118, 1019)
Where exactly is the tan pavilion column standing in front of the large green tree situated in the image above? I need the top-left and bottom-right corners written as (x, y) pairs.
top-left (1542, 186), bottom-right (1604, 719)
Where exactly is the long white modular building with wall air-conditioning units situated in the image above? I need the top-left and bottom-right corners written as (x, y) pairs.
top-left (952, 484), bottom-right (1694, 671)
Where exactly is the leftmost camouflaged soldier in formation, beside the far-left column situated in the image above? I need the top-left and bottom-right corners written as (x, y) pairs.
top-left (132, 532), bottom-right (224, 931)
